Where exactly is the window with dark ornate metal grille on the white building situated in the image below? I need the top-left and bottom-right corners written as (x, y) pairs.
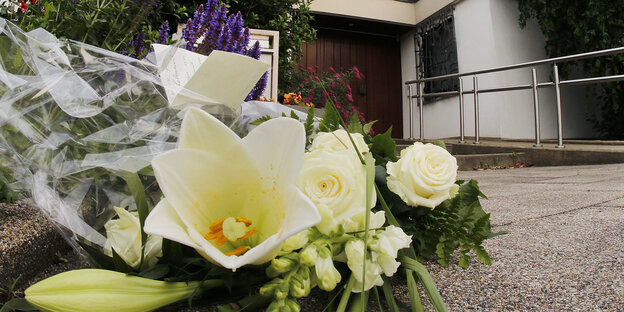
top-left (414, 8), bottom-right (459, 93)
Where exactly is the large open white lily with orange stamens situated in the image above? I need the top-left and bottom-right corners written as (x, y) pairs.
top-left (145, 108), bottom-right (321, 270)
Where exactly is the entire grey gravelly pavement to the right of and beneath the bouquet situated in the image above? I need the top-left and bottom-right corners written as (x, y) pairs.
top-left (0, 164), bottom-right (624, 312)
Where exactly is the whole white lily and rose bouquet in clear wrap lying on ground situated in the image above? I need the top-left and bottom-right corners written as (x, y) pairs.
top-left (0, 20), bottom-right (496, 311)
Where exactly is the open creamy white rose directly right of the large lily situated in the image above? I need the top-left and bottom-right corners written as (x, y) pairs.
top-left (297, 149), bottom-right (377, 226)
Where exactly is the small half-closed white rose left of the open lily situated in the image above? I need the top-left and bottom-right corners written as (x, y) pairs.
top-left (104, 207), bottom-right (162, 270)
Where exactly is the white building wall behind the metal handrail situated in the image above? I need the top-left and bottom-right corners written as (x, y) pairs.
top-left (401, 0), bottom-right (595, 139)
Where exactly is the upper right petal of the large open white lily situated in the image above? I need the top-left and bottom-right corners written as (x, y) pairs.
top-left (242, 117), bottom-right (305, 185)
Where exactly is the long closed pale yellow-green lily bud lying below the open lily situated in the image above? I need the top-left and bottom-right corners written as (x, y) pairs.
top-left (24, 269), bottom-right (201, 312)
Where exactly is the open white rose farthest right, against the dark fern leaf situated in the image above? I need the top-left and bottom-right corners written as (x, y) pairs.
top-left (386, 142), bottom-right (457, 209)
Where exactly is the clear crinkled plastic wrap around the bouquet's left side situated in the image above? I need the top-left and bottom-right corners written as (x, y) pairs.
top-left (0, 19), bottom-right (260, 252)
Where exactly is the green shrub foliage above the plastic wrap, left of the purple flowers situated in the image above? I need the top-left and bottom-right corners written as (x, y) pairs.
top-left (0, 0), bottom-right (185, 58)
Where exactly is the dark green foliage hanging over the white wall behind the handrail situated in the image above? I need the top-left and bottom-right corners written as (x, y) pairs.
top-left (518, 0), bottom-right (624, 139)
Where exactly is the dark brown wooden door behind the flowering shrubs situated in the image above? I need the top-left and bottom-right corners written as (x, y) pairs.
top-left (301, 30), bottom-right (403, 138)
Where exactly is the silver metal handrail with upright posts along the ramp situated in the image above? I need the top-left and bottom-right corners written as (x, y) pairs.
top-left (405, 47), bottom-right (624, 148)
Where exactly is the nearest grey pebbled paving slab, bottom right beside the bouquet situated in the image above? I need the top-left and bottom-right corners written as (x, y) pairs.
top-left (420, 208), bottom-right (624, 311)
